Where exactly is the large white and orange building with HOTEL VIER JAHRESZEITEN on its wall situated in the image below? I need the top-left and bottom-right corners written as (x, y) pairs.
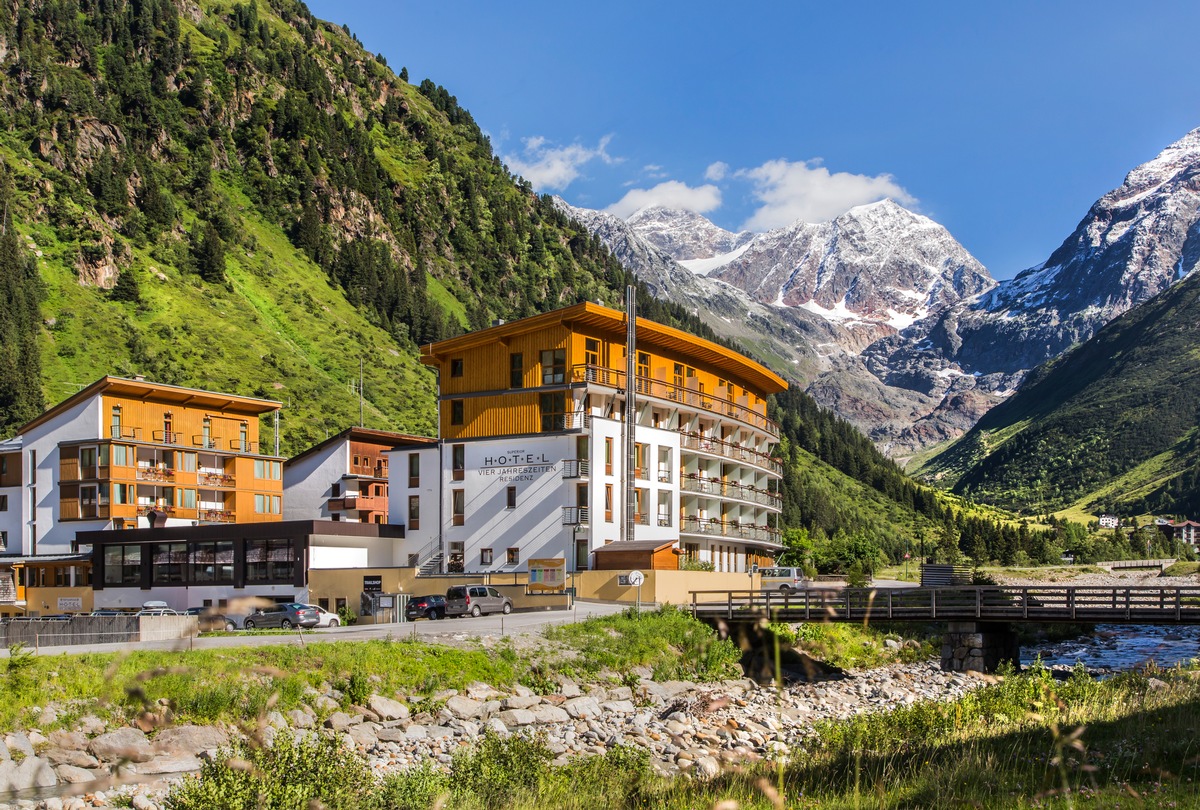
top-left (408, 302), bottom-right (787, 572)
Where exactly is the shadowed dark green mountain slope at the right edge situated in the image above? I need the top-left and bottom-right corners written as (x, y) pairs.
top-left (922, 267), bottom-right (1200, 515)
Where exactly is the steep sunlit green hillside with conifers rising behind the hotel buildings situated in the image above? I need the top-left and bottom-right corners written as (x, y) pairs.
top-left (0, 0), bottom-right (955, 547)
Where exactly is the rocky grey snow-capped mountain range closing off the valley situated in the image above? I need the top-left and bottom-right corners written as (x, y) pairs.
top-left (561, 130), bottom-right (1200, 456)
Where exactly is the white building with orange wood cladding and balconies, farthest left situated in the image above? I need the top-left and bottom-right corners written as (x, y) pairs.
top-left (0, 377), bottom-right (283, 610)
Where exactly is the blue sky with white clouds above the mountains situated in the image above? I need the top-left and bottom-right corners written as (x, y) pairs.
top-left (308, 0), bottom-right (1200, 278)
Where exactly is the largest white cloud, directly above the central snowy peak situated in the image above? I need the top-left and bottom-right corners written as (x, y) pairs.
top-left (734, 160), bottom-right (917, 230)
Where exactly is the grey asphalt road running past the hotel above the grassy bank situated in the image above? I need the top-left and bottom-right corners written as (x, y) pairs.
top-left (0, 601), bottom-right (629, 658)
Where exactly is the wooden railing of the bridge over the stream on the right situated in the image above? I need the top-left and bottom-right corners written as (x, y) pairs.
top-left (690, 586), bottom-right (1200, 624)
